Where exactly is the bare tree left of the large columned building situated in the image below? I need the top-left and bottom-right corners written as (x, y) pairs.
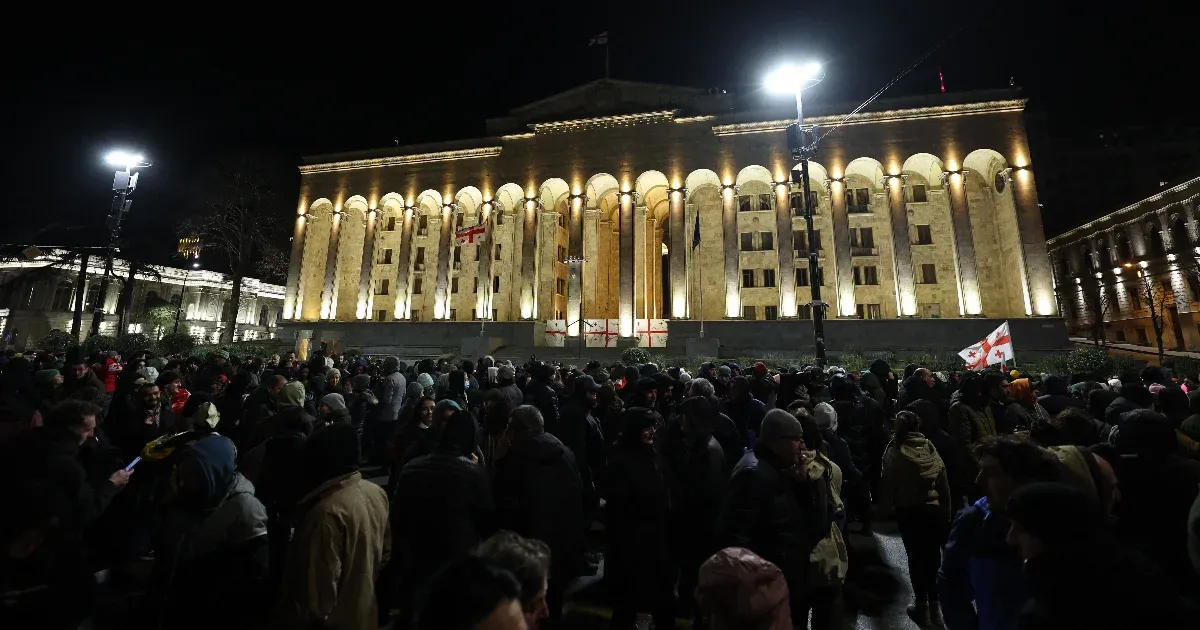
top-left (178, 152), bottom-right (287, 343)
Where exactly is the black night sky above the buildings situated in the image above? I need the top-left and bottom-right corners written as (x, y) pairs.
top-left (0, 0), bottom-right (1196, 267)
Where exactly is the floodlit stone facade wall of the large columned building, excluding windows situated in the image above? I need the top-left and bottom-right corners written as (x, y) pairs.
top-left (286, 82), bottom-right (1056, 343)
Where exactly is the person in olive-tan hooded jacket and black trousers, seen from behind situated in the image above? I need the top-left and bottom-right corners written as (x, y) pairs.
top-left (880, 412), bottom-right (953, 628)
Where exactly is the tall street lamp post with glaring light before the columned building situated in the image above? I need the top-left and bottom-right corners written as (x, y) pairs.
top-left (767, 62), bottom-right (826, 366)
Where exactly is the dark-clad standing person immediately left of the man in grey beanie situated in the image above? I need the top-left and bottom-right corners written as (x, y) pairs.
top-left (668, 396), bottom-right (727, 613)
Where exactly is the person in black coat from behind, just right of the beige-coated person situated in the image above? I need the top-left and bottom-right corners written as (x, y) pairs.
top-left (391, 404), bottom-right (494, 594)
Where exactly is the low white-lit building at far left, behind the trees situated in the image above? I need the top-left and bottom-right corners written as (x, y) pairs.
top-left (0, 252), bottom-right (283, 349)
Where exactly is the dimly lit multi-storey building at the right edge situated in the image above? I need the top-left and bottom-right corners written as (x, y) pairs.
top-left (1046, 178), bottom-right (1200, 350)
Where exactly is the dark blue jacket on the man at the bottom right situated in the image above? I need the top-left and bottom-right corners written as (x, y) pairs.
top-left (937, 497), bottom-right (1030, 630)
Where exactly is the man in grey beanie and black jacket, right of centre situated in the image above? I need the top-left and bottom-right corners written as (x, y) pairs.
top-left (718, 409), bottom-right (833, 610)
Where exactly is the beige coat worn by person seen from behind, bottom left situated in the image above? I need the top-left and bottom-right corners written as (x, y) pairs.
top-left (275, 473), bottom-right (391, 630)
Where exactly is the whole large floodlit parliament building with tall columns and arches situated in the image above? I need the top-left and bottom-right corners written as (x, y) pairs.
top-left (283, 79), bottom-right (1056, 348)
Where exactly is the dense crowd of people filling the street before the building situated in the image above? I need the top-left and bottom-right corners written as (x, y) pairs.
top-left (0, 352), bottom-right (1200, 630)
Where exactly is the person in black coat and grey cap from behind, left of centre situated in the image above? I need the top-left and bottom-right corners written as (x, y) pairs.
top-left (494, 404), bottom-right (589, 619)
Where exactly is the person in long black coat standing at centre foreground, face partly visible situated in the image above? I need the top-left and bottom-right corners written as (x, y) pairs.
top-left (605, 407), bottom-right (674, 629)
